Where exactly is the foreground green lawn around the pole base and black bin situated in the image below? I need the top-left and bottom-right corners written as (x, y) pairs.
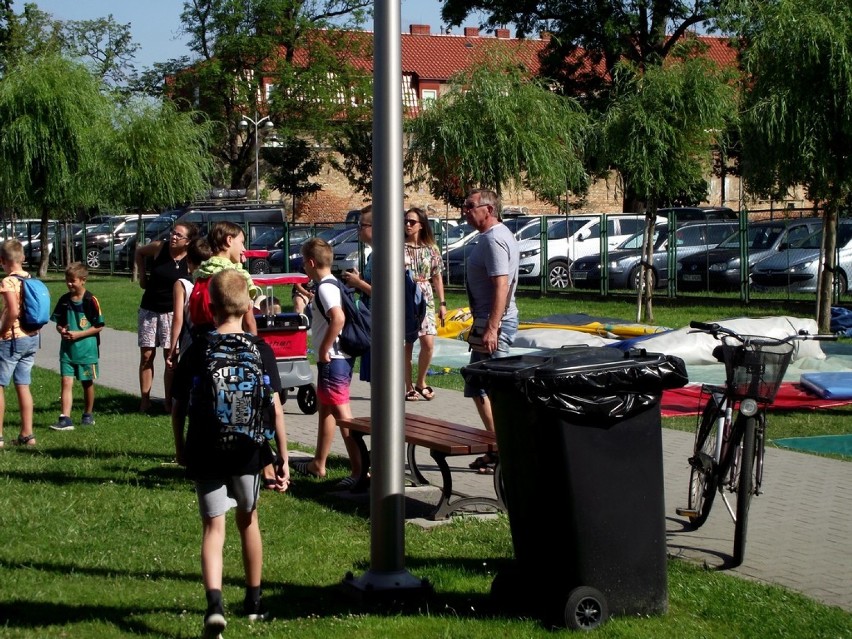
top-left (0, 370), bottom-right (852, 639)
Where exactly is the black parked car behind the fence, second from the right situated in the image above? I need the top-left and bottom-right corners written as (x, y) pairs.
top-left (677, 217), bottom-right (822, 291)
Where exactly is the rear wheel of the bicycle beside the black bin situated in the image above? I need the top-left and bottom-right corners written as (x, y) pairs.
top-left (687, 395), bottom-right (725, 528)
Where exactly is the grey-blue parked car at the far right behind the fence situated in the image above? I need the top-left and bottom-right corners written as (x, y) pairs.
top-left (751, 218), bottom-right (852, 295)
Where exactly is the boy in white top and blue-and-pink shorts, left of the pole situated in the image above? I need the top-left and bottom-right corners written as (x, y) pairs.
top-left (293, 238), bottom-right (361, 489)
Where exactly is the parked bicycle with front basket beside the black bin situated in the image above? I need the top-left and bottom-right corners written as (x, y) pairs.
top-left (676, 321), bottom-right (837, 567)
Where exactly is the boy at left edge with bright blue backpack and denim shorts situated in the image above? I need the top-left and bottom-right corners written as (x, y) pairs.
top-left (0, 240), bottom-right (45, 448)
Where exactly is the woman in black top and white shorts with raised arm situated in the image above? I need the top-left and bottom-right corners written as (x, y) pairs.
top-left (134, 222), bottom-right (198, 413)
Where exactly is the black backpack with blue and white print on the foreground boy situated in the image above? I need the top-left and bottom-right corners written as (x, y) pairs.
top-left (189, 332), bottom-right (274, 449)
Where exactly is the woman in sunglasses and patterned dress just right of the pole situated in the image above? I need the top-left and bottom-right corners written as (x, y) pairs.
top-left (405, 208), bottom-right (447, 402)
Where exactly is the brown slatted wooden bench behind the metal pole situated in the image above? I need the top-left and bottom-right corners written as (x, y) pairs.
top-left (337, 415), bottom-right (506, 520)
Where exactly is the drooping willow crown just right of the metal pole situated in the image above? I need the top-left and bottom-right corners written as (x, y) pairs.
top-left (406, 61), bottom-right (588, 208)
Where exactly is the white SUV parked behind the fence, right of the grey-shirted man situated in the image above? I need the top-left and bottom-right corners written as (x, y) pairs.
top-left (518, 213), bottom-right (645, 288)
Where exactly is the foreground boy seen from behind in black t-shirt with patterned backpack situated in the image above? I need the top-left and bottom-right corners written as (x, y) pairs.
top-left (172, 269), bottom-right (290, 639)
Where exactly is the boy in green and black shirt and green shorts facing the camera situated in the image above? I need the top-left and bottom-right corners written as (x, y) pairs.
top-left (50, 262), bottom-right (104, 430)
